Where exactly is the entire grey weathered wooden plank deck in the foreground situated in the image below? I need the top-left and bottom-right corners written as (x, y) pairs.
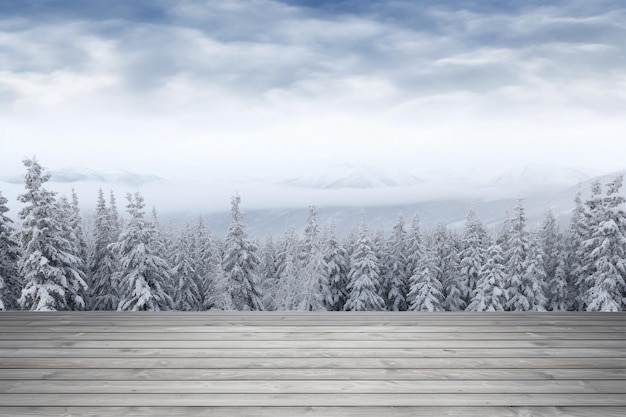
top-left (0, 312), bottom-right (626, 417)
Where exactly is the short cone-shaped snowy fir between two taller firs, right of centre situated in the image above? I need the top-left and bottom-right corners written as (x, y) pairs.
top-left (467, 243), bottom-right (507, 311)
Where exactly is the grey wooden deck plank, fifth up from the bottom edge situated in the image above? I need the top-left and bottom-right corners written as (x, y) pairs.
top-left (0, 357), bottom-right (626, 369)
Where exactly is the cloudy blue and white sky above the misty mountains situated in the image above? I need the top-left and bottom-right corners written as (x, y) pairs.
top-left (0, 0), bottom-right (626, 178)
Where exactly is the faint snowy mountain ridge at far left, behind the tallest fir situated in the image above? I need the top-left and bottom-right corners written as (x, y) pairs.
top-left (2, 167), bottom-right (163, 185)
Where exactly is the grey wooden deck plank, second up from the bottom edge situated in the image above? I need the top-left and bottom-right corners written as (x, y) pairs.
top-left (0, 393), bottom-right (626, 407)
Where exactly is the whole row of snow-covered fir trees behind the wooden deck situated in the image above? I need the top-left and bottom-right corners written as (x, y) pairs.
top-left (0, 158), bottom-right (626, 311)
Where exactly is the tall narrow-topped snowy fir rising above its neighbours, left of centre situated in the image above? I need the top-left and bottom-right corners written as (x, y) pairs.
top-left (223, 195), bottom-right (263, 310)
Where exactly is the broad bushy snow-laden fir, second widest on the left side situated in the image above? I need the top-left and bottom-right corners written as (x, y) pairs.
top-left (109, 192), bottom-right (173, 311)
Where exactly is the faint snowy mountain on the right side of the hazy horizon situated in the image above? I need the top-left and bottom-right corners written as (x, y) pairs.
top-left (490, 165), bottom-right (590, 187)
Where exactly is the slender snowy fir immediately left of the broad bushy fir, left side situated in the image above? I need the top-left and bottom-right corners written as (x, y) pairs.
top-left (89, 189), bottom-right (119, 311)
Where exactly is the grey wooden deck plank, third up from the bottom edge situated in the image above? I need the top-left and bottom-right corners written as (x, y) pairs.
top-left (0, 380), bottom-right (626, 395)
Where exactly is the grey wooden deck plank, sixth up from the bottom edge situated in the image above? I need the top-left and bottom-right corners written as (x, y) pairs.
top-left (0, 342), bottom-right (626, 358)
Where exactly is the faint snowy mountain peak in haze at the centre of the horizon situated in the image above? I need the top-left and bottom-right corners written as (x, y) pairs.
top-left (282, 164), bottom-right (422, 189)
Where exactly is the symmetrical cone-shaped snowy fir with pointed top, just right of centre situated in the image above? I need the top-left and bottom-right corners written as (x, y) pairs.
top-left (344, 217), bottom-right (385, 311)
